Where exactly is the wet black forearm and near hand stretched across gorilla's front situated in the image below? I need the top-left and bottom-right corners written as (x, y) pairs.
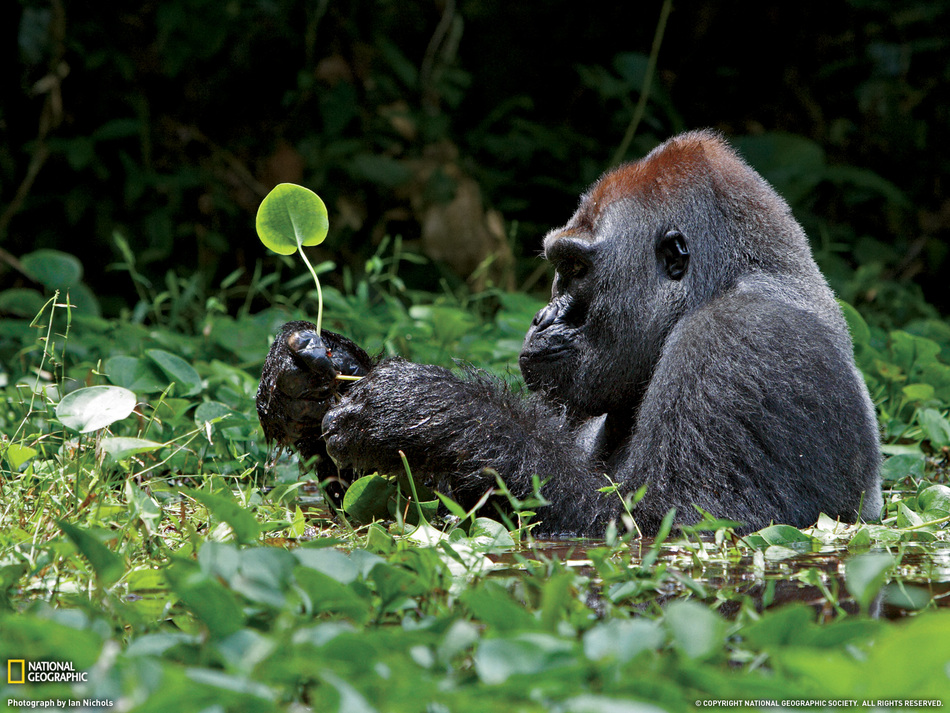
top-left (323, 359), bottom-right (619, 535)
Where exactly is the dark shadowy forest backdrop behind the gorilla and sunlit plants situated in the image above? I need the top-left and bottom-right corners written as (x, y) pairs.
top-left (0, 0), bottom-right (950, 326)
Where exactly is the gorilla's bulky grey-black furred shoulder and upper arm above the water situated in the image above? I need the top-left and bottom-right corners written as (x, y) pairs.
top-left (621, 287), bottom-right (882, 532)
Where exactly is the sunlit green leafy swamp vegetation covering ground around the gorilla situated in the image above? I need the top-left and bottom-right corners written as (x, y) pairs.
top-left (0, 245), bottom-right (950, 712)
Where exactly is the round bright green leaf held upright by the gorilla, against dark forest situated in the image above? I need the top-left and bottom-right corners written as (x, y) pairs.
top-left (257, 183), bottom-right (330, 255)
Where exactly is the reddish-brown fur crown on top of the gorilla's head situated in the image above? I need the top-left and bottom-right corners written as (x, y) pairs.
top-left (558, 130), bottom-right (777, 236)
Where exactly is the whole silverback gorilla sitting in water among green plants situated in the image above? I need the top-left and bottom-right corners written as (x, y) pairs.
top-left (257, 131), bottom-right (882, 535)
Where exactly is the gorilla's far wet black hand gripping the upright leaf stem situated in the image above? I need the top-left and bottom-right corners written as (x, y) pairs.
top-left (257, 321), bottom-right (373, 458)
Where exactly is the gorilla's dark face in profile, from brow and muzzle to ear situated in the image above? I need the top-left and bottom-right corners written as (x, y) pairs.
top-left (519, 193), bottom-right (690, 418)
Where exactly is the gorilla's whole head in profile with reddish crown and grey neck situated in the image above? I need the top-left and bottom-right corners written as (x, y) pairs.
top-left (520, 131), bottom-right (850, 418)
